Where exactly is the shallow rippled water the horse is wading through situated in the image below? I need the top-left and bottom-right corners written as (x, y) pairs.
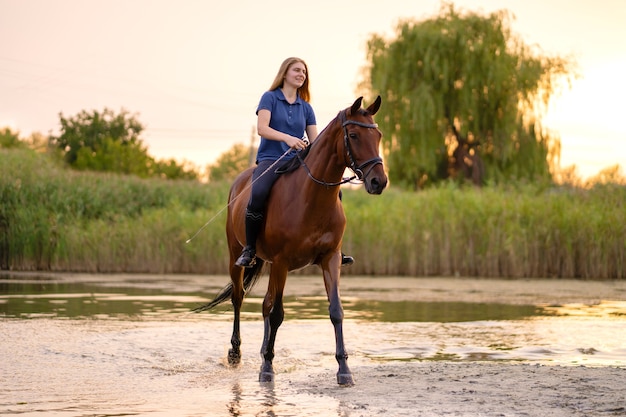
top-left (0, 274), bottom-right (626, 416)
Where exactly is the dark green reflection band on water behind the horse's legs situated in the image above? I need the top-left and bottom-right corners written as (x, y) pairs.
top-left (0, 279), bottom-right (544, 323)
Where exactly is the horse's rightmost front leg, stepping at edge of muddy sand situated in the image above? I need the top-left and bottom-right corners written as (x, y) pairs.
top-left (323, 253), bottom-right (354, 386)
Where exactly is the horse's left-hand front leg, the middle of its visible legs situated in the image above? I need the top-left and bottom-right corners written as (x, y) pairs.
top-left (259, 264), bottom-right (287, 382)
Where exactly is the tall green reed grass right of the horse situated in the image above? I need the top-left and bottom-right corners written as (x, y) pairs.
top-left (343, 184), bottom-right (626, 279)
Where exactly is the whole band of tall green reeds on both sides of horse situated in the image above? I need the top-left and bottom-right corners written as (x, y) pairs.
top-left (0, 150), bottom-right (626, 279)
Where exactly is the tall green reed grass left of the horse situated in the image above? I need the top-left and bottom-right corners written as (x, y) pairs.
top-left (0, 150), bottom-right (228, 273)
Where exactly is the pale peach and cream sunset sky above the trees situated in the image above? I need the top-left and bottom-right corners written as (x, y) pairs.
top-left (0, 0), bottom-right (626, 177)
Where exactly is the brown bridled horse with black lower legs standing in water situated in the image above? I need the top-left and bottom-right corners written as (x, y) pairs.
top-left (195, 97), bottom-right (387, 385)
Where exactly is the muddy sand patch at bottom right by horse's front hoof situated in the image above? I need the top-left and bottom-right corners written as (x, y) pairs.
top-left (302, 362), bottom-right (626, 417)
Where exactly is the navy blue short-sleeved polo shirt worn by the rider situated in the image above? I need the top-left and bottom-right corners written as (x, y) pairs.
top-left (256, 88), bottom-right (317, 163)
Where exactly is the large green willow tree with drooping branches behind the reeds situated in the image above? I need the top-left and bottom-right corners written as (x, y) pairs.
top-left (365, 3), bottom-right (574, 188)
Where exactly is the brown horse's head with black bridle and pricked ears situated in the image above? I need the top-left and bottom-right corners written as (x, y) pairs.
top-left (340, 96), bottom-right (387, 194)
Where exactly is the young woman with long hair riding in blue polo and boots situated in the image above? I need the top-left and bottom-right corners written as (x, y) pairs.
top-left (235, 57), bottom-right (354, 268)
